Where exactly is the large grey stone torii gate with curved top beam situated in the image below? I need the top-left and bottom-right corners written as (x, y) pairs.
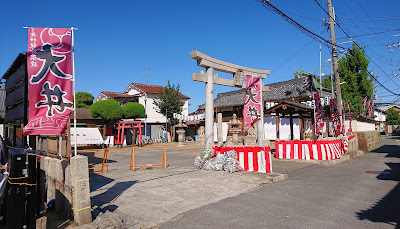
top-left (190, 50), bottom-right (271, 149)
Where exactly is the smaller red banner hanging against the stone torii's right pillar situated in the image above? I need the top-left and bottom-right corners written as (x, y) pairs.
top-left (243, 76), bottom-right (262, 130)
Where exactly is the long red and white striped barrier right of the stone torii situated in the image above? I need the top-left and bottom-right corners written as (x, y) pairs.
top-left (275, 139), bottom-right (343, 160)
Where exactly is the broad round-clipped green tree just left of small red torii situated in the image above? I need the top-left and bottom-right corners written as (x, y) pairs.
top-left (90, 99), bottom-right (122, 139)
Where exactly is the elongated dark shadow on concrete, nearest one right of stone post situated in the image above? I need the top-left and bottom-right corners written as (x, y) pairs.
top-left (90, 181), bottom-right (137, 219)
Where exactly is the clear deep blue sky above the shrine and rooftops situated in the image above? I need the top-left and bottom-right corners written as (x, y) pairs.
top-left (0, 0), bottom-right (400, 112)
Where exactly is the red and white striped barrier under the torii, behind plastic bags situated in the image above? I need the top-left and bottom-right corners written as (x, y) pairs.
top-left (213, 147), bottom-right (272, 173)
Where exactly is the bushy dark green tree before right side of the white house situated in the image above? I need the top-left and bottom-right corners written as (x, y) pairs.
top-left (153, 81), bottom-right (185, 125)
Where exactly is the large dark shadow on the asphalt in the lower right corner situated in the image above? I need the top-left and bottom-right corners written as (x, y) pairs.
top-left (357, 159), bottom-right (400, 229)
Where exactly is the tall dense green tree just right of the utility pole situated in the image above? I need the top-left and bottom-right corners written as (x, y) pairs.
top-left (339, 43), bottom-right (374, 110)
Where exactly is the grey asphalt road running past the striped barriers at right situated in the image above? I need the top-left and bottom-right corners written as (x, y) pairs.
top-left (160, 136), bottom-right (400, 229)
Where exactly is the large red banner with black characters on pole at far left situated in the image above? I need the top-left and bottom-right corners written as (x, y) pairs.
top-left (23, 28), bottom-right (73, 135)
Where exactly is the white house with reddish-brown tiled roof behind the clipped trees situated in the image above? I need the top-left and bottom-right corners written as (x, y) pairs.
top-left (96, 83), bottom-right (190, 138)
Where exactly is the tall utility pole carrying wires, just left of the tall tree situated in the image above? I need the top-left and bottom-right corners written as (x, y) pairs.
top-left (327, 0), bottom-right (343, 129)
